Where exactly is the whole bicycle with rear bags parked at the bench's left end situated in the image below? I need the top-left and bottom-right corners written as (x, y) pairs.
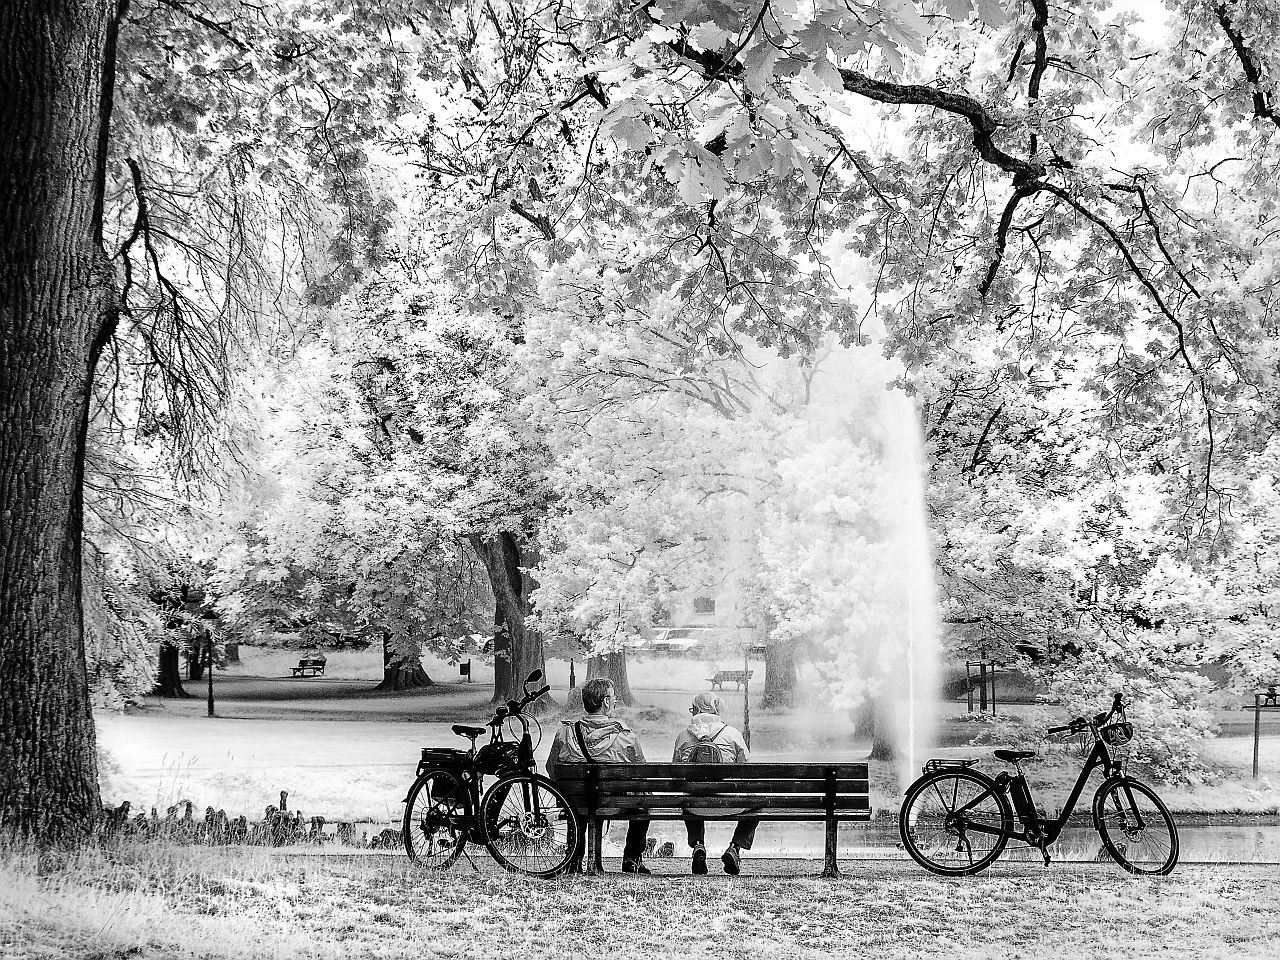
top-left (402, 669), bottom-right (582, 877)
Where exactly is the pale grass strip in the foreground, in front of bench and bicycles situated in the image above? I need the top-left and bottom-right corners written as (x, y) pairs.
top-left (0, 844), bottom-right (1280, 960)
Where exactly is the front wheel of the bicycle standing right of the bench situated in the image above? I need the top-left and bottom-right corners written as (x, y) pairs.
top-left (1093, 777), bottom-right (1178, 877)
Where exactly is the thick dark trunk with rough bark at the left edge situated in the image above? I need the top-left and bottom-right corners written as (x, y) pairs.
top-left (0, 0), bottom-right (116, 842)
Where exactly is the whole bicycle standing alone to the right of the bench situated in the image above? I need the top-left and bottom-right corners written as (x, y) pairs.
top-left (899, 694), bottom-right (1178, 877)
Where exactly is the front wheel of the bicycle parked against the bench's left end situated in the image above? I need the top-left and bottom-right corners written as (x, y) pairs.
top-left (480, 773), bottom-right (581, 877)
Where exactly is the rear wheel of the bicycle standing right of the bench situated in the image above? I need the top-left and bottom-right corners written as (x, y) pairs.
top-left (897, 769), bottom-right (1014, 877)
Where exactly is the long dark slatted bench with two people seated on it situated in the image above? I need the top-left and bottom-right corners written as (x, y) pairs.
top-left (556, 763), bottom-right (872, 877)
